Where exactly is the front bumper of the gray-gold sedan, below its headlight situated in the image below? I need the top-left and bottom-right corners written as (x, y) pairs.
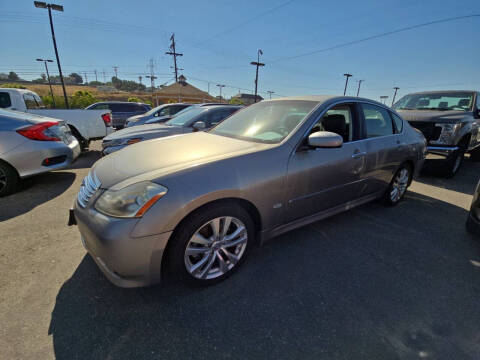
top-left (73, 201), bottom-right (172, 287)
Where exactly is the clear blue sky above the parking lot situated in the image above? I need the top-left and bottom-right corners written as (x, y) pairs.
top-left (0, 0), bottom-right (480, 99)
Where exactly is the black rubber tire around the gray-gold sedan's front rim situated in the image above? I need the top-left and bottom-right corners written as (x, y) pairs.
top-left (165, 202), bottom-right (255, 286)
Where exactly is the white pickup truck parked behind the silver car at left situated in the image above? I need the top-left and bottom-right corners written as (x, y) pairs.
top-left (0, 88), bottom-right (113, 150)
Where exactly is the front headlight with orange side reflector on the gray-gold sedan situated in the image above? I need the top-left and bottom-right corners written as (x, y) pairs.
top-left (95, 181), bottom-right (168, 217)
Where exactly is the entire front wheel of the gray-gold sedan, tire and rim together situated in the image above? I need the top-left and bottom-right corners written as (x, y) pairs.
top-left (166, 202), bottom-right (255, 285)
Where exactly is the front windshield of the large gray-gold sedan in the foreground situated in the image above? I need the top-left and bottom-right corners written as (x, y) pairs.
top-left (211, 100), bottom-right (318, 143)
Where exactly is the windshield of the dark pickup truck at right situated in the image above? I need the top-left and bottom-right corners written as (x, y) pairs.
top-left (393, 92), bottom-right (473, 111)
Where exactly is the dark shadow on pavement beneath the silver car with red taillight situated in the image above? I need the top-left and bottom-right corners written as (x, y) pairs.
top-left (0, 171), bottom-right (75, 222)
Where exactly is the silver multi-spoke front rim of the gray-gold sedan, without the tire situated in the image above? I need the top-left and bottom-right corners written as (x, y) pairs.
top-left (184, 216), bottom-right (248, 280)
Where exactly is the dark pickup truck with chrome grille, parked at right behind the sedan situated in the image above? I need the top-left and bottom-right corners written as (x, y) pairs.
top-left (393, 91), bottom-right (480, 177)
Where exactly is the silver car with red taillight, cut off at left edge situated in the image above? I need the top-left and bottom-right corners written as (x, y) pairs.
top-left (0, 109), bottom-right (80, 197)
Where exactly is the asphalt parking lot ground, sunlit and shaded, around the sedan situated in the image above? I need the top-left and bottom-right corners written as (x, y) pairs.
top-left (0, 143), bottom-right (480, 359)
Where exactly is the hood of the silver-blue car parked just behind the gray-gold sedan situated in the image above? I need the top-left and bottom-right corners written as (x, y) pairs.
top-left (103, 124), bottom-right (185, 143)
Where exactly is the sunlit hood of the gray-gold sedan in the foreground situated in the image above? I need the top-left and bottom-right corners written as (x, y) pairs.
top-left (92, 131), bottom-right (274, 190)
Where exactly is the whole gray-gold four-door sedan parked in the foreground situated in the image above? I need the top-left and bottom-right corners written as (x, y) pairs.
top-left (70, 96), bottom-right (426, 287)
